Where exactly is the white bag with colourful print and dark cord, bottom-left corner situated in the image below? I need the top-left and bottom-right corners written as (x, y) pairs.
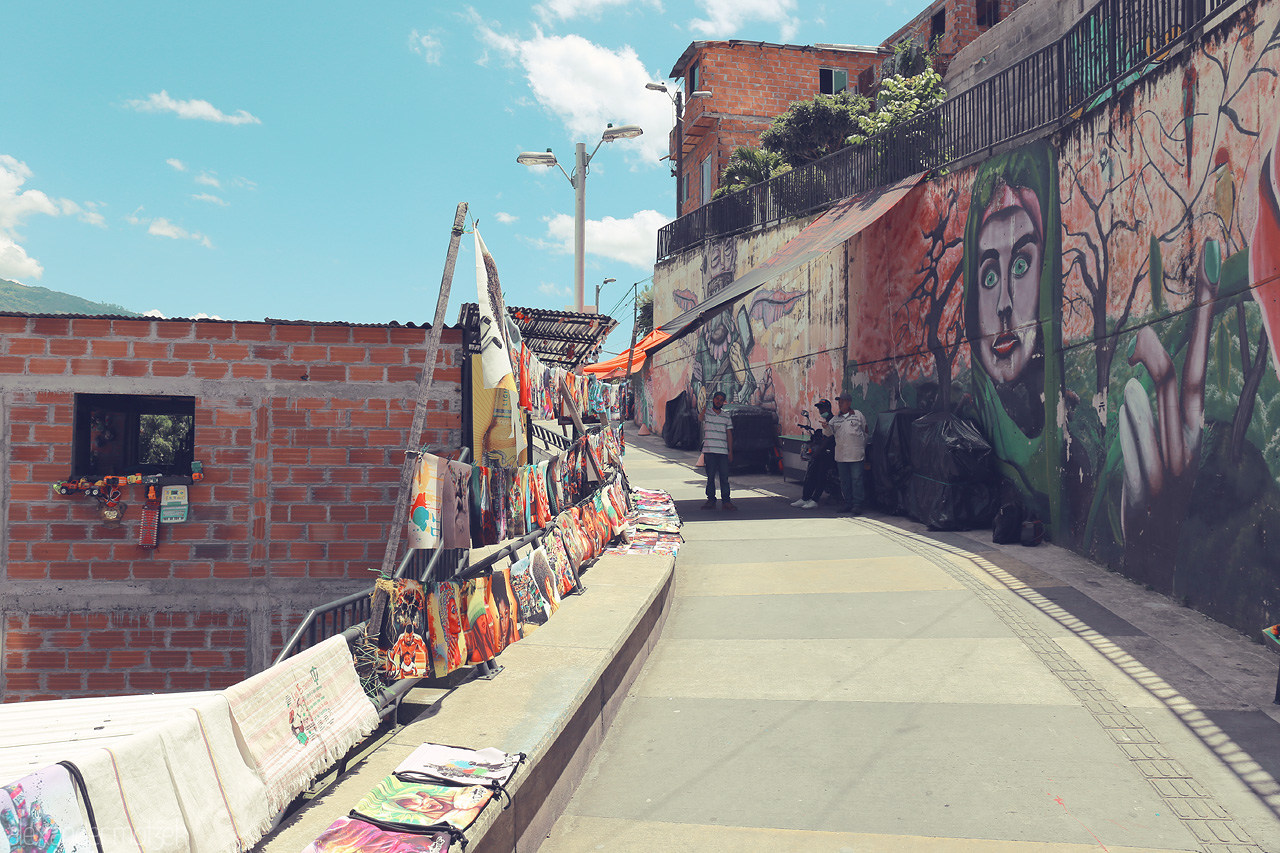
top-left (0, 765), bottom-right (97, 853)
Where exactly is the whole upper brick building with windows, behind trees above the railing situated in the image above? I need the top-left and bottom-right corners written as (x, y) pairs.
top-left (671, 40), bottom-right (888, 215)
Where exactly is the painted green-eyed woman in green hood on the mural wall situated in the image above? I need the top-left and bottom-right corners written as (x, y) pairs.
top-left (964, 142), bottom-right (1064, 535)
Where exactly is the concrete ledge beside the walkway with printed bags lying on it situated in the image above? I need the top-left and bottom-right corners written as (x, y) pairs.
top-left (256, 555), bottom-right (675, 853)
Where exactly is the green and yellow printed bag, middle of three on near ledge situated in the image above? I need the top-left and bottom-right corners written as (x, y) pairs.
top-left (351, 776), bottom-right (494, 831)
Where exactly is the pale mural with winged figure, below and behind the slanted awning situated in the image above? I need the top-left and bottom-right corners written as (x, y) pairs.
top-left (643, 225), bottom-right (844, 432)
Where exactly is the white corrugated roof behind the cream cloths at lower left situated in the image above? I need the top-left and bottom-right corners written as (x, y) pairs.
top-left (0, 690), bottom-right (218, 785)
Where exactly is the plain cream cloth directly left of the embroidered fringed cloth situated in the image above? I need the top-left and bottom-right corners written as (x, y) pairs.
top-left (160, 695), bottom-right (275, 853)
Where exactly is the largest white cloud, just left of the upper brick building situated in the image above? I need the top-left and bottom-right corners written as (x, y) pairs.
top-left (476, 20), bottom-right (675, 164)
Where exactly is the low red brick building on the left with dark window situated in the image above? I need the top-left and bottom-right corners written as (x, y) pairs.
top-left (0, 315), bottom-right (462, 702)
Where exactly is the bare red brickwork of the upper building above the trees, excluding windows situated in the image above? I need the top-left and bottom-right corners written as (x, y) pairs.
top-left (671, 42), bottom-right (882, 214)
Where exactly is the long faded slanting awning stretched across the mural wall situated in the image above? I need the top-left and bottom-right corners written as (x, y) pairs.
top-left (650, 172), bottom-right (927, 348)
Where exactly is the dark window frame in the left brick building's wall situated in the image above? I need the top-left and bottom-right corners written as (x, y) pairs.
top-left (72, 393), bottom-right (196, 479)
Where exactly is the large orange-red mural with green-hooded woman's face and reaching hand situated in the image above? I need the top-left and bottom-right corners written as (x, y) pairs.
top-left (846, 3), bottom-right (1280, 630)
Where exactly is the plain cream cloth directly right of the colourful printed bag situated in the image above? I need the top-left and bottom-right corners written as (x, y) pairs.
top-left (72, 729), bottom-right (189, 853)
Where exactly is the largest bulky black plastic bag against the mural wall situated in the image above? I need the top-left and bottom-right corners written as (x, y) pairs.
top-left (911, 411), bottom-right (997, 530)
